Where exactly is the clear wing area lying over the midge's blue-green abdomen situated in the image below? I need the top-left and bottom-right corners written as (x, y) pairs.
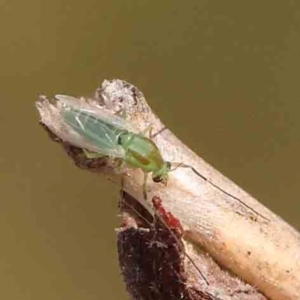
top-left (61, 107), bottom-right (125, 157)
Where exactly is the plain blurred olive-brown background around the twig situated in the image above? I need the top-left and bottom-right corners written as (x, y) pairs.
top-left (0, 0), bottom-right (300, 300)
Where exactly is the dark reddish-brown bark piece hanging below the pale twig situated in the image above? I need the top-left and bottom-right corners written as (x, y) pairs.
top-left (117, 193), bottom-right (209, 300)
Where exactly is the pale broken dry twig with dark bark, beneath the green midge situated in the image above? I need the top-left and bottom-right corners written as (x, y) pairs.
top-left (39, 80), bottom-right (300, 300)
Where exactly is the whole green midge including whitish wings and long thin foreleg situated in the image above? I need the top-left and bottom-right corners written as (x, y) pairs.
top-left (56, 95), bottom-right (268, 220)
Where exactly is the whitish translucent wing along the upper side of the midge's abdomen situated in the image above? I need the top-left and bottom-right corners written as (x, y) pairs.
top-left (55, 95), bottom-right (138, 133)
